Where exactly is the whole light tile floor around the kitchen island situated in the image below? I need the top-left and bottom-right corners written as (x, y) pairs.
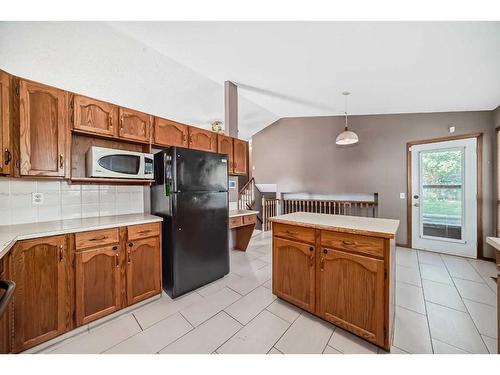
top-left (31, 232), bottom-right (497, 354)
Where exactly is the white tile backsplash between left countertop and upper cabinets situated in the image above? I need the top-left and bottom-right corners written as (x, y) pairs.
top-left (0, 177), bottom-right (144, 225)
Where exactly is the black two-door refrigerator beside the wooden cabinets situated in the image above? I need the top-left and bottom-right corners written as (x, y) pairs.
top-left (151, 147), bottom-right (229, 298)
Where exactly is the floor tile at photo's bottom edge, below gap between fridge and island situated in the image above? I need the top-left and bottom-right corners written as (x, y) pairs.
top-left (217, 310), bottom-right (290, 354)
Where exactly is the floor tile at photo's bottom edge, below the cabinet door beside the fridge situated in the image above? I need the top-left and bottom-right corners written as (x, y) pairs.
top-left (106, 313), bottom-right (193, 354)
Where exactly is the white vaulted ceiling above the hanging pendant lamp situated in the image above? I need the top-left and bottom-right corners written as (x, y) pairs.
top-left (111, 22), bottom-right (500, 122)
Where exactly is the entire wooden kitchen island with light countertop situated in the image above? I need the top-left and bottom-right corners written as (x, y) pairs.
top-left (270, 212), bottom-right (399, 351)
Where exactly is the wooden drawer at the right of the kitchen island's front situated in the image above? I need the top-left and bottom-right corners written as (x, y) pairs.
top-left (321, 230), bottom-right (384, 258)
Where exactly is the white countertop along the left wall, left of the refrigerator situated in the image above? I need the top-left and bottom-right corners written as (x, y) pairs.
top-left (0, 213), bottom-right (163, 258)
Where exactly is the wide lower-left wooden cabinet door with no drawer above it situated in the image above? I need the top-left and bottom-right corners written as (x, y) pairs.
top-left (11, 236), bottom-right (71, 353)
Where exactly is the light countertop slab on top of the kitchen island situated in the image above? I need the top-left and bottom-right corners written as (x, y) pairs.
top-left (269, 212), bottom-right (399, 239)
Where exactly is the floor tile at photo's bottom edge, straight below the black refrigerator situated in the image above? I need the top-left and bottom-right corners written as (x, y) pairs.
top-left (160, 312), bottom-right (242, 354)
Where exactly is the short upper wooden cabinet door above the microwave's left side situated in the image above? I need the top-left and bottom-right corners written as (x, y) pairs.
top-left (71, 95), bottom-right (118, 136)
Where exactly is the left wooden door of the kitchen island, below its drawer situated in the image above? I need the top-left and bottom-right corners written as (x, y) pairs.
top-left (273, 238), bottom-right (316, 312)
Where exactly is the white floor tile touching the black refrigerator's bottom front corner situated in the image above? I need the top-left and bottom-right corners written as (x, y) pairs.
top-left (134, 292), bottom-right (203, 329)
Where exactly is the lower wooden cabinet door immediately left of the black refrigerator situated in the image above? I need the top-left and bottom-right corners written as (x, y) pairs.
top-left (127, 237), bottom-right (161, 305)
